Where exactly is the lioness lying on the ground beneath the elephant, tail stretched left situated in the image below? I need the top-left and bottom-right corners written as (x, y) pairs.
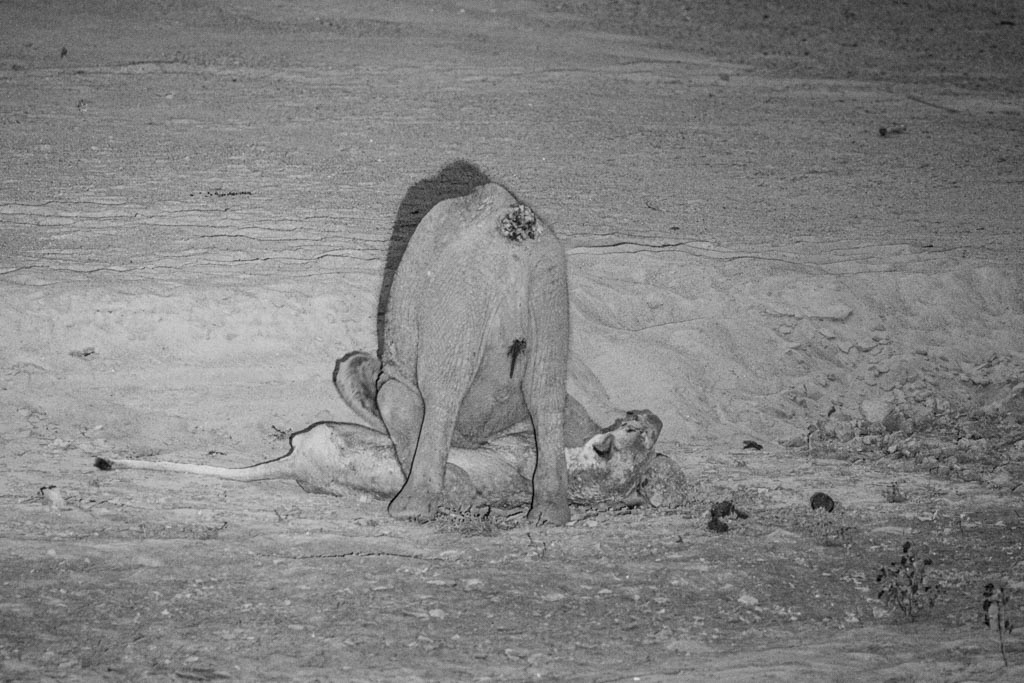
top-left (95, 411), bottom-right (662, 507)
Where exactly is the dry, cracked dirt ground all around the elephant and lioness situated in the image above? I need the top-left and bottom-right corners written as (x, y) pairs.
top-left (0, 0), bottom-right (1024, 682)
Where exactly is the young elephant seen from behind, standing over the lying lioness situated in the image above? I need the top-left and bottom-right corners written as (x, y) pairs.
top-left (377, 183), bottom-right (569, 524)
